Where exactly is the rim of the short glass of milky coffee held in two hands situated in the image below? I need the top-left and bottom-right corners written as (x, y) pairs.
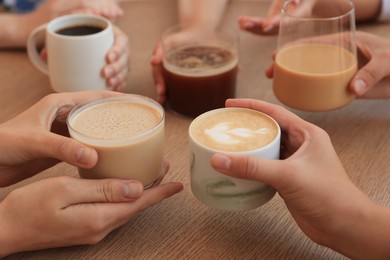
top-left (66, 94), bottom-right (165, 146)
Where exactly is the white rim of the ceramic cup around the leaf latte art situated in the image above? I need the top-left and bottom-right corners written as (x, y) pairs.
top-left (188, 107), bottom-right (281, 155)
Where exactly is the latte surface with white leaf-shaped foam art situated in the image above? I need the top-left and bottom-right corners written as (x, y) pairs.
top-left (190, 108), bottom-right (278, 152)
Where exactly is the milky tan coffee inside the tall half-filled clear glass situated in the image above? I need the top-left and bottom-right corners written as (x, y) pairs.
top-left (273, 44), bottom-right (357, 111)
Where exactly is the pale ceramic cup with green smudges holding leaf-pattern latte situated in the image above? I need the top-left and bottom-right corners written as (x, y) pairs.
top-left (189, 108), bottom-right (281, 211)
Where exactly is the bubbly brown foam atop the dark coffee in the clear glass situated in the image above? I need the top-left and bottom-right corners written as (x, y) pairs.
top-left (163, 43), bottom-right (238, 77)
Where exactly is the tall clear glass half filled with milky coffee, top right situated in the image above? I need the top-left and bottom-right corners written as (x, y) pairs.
top-left (273, 0), bottom-right (358, 111)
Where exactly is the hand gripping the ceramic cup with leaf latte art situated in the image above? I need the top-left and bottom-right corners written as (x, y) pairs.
top-left (211, 99), bottom-right (374, 258)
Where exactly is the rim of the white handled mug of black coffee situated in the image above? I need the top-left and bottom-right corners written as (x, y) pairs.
top-left (46, 14), bottom-right (112, 39)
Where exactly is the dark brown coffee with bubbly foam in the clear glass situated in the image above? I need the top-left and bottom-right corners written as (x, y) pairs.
top-left (163, 43), bottom-right (238, 117)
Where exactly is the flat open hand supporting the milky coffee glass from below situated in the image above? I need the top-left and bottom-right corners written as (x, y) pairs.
top-left (0, 164), bottom-right (183, 257)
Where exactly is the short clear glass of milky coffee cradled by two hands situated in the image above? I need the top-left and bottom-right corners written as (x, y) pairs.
top-left (67, 95), bottom-right (165, 188)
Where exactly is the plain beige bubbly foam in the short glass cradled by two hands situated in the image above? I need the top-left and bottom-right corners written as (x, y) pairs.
top-left (70, 101), bottom-right (162, 140)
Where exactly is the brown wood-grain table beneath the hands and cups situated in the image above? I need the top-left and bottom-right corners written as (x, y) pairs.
top-left (0, 0), bottom-right (390, 259)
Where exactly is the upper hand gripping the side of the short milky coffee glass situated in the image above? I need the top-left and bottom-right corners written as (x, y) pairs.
top-left (0, 91), bottom-right (123, 187)
